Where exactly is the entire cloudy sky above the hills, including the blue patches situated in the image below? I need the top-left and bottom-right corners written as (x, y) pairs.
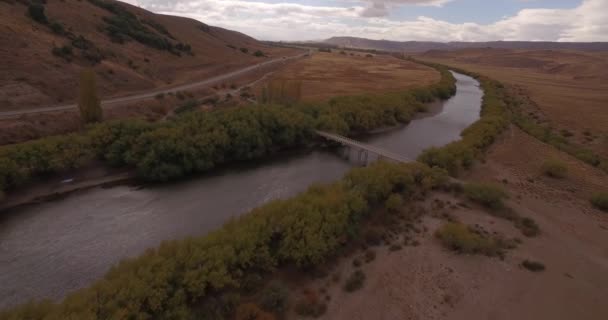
top-left (123, 0), bottom-right (608, 41)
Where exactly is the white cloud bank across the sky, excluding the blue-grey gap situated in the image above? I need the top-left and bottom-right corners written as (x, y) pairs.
top-left (121, 0), bottom-right (608, 41)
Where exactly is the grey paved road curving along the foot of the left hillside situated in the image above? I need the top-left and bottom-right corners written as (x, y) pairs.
top-left (0, 52), bottom-right (308, 118)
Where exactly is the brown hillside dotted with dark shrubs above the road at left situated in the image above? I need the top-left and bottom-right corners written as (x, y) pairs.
top-left (0, 0), bottom-right (300, 110)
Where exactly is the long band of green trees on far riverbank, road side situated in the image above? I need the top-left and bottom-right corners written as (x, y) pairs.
top-left (0, 69), bottom-right (455, 198)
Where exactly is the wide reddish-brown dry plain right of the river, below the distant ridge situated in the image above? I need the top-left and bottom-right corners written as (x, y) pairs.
top-left (421, 49), bottom-right (608, 157)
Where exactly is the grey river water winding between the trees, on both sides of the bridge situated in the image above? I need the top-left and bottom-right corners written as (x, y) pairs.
top-left (0, 74), bottom-right (483, 308)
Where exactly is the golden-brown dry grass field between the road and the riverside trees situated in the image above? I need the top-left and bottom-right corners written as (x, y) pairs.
top-left (258, 51), bottom-right (439, 101)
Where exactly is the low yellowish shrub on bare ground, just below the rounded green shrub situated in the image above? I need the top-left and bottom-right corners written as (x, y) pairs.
top-left (435, 222), bottom-right (503, 256)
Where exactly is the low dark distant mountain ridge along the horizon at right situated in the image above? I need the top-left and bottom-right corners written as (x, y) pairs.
top-left (323, 37), bottom-right (608, 53)
